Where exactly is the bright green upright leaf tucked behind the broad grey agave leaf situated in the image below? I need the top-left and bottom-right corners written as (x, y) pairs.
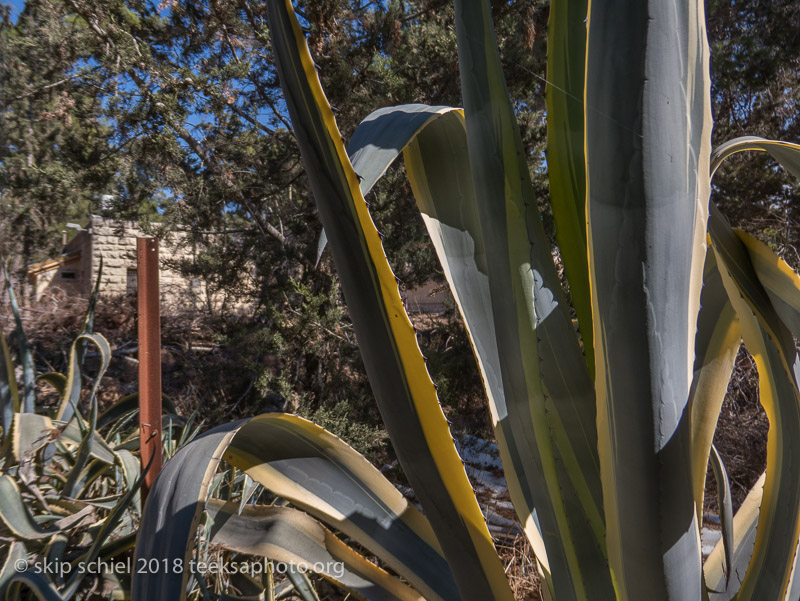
top-left (545, 0), bottom-right (594, 376)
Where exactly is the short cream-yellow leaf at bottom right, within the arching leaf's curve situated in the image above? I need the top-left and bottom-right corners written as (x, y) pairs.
top-left (703, 473), bottom-right (766, 601)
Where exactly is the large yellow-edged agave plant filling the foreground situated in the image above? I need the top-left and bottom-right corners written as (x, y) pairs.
top-left (133, 0), bottom-right (800, 601)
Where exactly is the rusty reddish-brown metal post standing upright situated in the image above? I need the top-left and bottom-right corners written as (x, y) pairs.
top-left (136, 238), bottom-right (161, 503)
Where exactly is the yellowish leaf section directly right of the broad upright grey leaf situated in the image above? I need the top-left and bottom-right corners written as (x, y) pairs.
top-left (689, 252), bottom-right (742, 510)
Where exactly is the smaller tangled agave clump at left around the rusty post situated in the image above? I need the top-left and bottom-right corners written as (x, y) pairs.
top-left (0, 267), bottom-right (198, 601)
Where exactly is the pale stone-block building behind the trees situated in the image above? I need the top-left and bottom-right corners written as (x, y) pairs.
top-left (28, 215), bottom-right (216, 307)
